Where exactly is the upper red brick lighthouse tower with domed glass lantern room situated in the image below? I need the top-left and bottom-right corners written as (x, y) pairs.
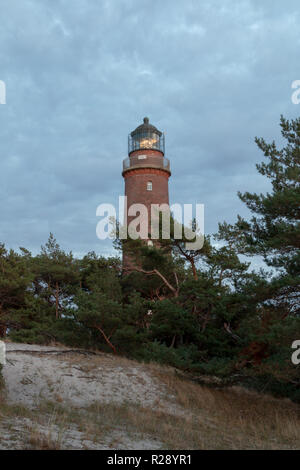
top-left (122, 117), bottom-right (171, 270)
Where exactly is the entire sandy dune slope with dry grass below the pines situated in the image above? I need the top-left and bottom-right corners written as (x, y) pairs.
top-left (0, 342), bottom-right (299, 450)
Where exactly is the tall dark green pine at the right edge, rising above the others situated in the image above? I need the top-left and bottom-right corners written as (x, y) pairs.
top-left (214, 117), bottom-right (300, 400)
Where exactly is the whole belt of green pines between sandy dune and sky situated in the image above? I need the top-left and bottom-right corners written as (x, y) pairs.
top-left (0, 118), bottom-right (300, 401)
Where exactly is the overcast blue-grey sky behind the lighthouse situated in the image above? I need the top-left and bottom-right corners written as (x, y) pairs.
top-left (0, 0), bottom-right (300, 256)
